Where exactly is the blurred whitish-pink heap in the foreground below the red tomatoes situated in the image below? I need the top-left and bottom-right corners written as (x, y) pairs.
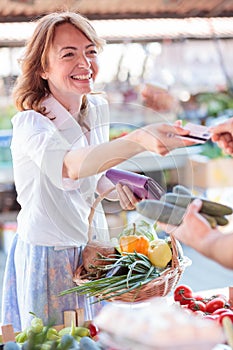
top-left (94, 298), bottom-right (225, 350)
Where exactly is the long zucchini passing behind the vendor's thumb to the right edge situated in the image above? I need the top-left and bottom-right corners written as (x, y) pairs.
top-left (160, 193), bottom-right (233, 216)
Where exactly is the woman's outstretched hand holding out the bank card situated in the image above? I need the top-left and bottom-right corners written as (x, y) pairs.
top-left (139, 121), bottom-right (195, 155)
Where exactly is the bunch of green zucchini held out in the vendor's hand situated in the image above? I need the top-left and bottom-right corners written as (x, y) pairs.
top-left (136, 186), bottom-right (233, 228)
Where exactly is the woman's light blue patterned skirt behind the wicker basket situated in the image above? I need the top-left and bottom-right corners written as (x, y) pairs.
top-left (1, 234), bottom-right (102, 332)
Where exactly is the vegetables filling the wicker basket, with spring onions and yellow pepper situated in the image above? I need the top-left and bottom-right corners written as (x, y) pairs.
top-left (60, 220), bottom-right (186, 302)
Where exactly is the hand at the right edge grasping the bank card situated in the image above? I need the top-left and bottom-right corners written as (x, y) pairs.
top-left (210, 118), bottom-right (233, 156)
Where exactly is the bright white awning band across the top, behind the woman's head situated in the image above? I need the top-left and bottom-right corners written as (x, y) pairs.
top-left (0, 17), bottom-right (233, 47)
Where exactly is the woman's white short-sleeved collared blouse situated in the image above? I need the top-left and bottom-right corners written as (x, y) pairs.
top-left (11, 95), bottom-right (109, 249)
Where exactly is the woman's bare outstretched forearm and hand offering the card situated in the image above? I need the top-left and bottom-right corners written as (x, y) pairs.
top-left (63, 123), bottom-right (193, 180)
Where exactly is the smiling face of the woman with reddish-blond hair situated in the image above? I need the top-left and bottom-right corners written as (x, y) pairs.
top-left (41, 23), bottom-right (97, 111)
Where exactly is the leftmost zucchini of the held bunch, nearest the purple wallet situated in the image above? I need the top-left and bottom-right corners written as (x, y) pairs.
top-left (136, 199), bottom-right (186, 226)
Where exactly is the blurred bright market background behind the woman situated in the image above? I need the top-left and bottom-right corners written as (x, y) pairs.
top-left (0, 0), bottom-right (233, 318)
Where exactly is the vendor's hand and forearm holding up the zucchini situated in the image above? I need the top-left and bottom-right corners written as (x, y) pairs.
top-left (159, 199), bottom-right (233, 269)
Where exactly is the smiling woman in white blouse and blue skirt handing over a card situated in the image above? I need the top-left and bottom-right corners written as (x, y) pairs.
top-left (2, 12), bottom-right (194, 331)
